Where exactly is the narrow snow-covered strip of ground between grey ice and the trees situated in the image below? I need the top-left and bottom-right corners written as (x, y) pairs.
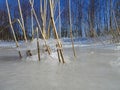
top-left (0, 37), bottom-right (120, 50)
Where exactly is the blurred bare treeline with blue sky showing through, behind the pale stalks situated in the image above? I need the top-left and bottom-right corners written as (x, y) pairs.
top-left (0, 0), bottom-right (120, 40)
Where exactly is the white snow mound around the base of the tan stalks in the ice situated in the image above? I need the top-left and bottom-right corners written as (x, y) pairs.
top-left (17, 39), bottom-right (70, 63)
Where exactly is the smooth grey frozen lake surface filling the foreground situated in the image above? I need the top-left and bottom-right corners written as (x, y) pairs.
top-left (0, 47), bottom-right (120, 90)
